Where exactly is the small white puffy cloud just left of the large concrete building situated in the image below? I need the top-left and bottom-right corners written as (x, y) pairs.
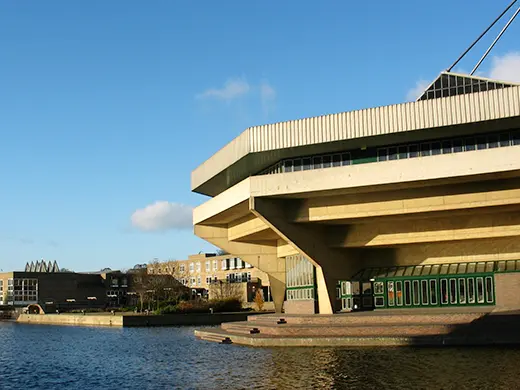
top-left (131, 200), bottom-right (193, 232)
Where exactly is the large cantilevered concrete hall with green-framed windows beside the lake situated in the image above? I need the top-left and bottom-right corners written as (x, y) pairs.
top-left (192, 73), bottom-right (520, 314)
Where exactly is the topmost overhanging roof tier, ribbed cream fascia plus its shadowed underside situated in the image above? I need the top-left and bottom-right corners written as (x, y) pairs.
top-left (191, 79), bottom-right (520, 196)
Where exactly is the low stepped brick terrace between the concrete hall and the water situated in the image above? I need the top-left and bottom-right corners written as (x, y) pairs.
top-left (195, 310), bottom-right (520, 347)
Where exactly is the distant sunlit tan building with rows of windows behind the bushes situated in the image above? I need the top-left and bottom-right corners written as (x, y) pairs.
top-left (148, 253), bottom-right (271, 306)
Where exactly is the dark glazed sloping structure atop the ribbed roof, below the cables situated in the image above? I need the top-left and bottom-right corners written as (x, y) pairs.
top-left (417, 72), bottom-right (520, 101)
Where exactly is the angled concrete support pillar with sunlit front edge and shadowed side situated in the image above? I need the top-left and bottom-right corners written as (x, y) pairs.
top-left (249, 198), bottom-right (358, 314)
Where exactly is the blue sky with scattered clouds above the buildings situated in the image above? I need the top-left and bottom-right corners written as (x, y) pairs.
top-left (0, 0), bottom-right (520, 271)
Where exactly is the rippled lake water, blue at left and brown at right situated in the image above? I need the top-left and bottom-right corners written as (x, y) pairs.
top-left (0, 322), bottom-right (520, 390)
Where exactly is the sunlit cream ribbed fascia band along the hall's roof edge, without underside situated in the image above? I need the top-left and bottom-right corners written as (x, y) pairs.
top-left (192, 87), bottom-right (520, 193)
